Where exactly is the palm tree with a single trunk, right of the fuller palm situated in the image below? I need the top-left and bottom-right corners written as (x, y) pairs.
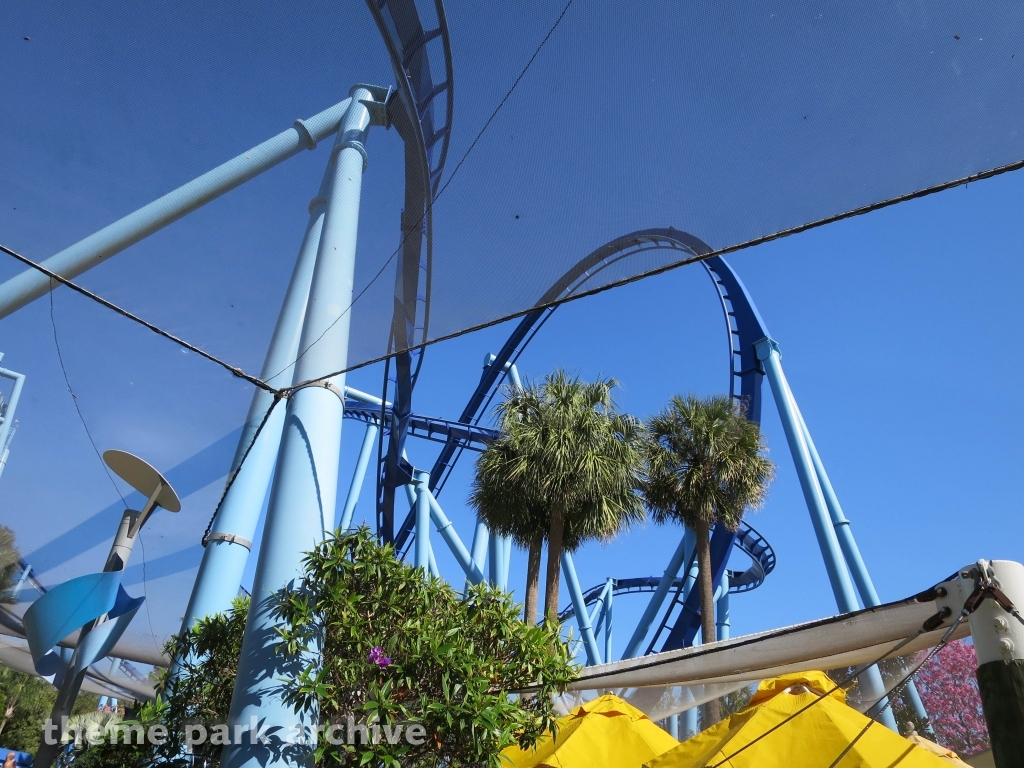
top-left (643, 394), bottom-right (775, 725)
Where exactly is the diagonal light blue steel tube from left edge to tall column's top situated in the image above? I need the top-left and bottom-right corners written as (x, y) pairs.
top-left (0, 99), bottom-right (356, 317)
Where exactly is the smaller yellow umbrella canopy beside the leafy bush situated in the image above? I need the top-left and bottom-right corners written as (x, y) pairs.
top-left (502, 694), bottom-right (679, 768)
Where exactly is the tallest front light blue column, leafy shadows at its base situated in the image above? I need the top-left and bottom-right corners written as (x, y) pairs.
top-left (221, 86), bottom-right (386, 768)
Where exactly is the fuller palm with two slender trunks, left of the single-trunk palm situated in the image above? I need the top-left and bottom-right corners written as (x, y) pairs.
top-left (470, 371), bottom-right (643, 622)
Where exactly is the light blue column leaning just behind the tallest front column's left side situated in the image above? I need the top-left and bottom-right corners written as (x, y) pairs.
top-left (181, 166), bottom-right (329, 632)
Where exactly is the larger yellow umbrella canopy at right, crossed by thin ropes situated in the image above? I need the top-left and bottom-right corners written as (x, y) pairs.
top-left (646, 672), bottom-right (949, 768)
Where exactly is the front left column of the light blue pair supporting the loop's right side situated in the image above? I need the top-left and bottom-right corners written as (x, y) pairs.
top-left (754, 337), bottom-right (898, 732)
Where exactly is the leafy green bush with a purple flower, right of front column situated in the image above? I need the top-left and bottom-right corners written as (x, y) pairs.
top-left (278, 527), bottom-right (575, 768)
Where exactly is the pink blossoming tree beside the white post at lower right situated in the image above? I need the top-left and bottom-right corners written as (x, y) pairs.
top-left (914, 640), bottom-right (989, 756)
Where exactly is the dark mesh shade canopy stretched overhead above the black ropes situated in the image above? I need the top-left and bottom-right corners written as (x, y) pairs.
top-left (0, 0), bottom-right (1024, 651)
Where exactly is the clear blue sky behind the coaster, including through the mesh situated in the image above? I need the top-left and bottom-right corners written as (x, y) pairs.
top-left (0, 3), bottom-right (1024, 663)
